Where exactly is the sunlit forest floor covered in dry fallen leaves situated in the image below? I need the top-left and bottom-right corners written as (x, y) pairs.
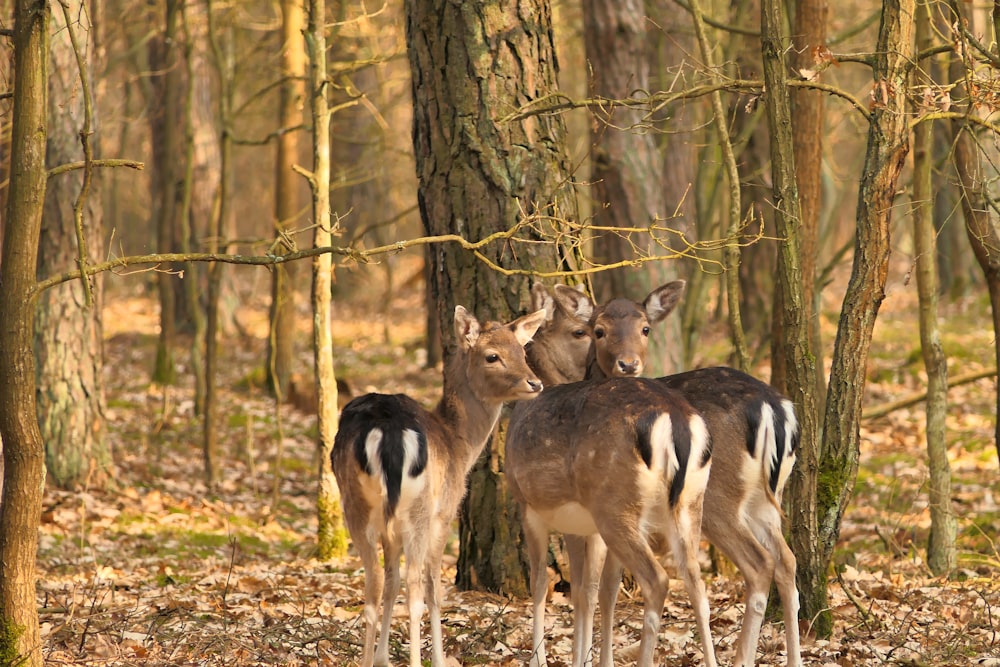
top-left (38, 264), bottom-right (1000, 667)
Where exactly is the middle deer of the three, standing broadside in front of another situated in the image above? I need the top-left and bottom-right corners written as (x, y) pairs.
top-left (504, 285), bottom-right (716, 667)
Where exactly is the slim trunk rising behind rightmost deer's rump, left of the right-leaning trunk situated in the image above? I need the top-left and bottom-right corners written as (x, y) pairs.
top-left (761, 0), bottom-right (824, 636)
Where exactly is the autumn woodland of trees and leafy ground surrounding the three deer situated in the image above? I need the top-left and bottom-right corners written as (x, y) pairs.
top-left (0, 0), bottom-right (1000, 664)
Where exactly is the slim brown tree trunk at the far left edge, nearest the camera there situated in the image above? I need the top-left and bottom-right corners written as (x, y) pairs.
top-left (0, 0), bottom-right (51, 667)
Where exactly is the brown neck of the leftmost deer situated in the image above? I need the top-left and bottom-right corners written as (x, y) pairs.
top-left (435, 354), bottom-right (503, 472)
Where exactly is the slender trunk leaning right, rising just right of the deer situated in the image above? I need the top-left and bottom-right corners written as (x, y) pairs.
top-left (820, 0), bottom-right (915, 634)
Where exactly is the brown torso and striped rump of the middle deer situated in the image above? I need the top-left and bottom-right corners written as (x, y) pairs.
top-left (505, 378), bottom-right (711, 534)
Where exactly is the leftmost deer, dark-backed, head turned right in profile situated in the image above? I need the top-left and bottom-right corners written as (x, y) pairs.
top-left (331, 306), bottom-right (545, 667)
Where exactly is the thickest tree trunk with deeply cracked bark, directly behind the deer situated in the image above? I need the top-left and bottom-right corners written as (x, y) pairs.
top-left (405, 0), bottom-right (577, 595)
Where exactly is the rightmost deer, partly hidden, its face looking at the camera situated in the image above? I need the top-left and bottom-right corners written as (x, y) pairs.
top-left (537, 285), bottom-right (802, 667)
